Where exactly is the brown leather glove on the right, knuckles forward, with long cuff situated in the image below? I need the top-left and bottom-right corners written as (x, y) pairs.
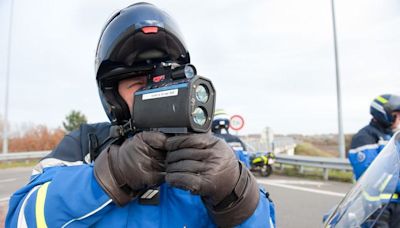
top-left (165, 134), bottom-right (259, 227)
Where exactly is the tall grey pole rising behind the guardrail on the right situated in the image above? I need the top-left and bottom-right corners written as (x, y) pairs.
top-left (331, 0), bottom-right (345, 158)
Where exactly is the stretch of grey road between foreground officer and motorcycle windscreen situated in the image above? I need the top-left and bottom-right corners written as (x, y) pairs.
top-left (257, 176), bottom-right (352, 228)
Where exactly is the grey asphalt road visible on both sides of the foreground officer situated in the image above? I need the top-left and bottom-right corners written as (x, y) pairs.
top-left (0, 168), bottom-right (352, 228)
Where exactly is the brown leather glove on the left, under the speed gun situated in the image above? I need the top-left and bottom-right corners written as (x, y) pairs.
top-left (94, 132), bottom-right (166, 206)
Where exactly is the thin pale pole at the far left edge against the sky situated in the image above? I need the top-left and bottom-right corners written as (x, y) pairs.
top-left (3, 0), bottom-right (14, 154)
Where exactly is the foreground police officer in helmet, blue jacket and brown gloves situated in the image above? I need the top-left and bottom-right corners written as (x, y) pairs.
top-left (6, 3), bottom-right (275, 227)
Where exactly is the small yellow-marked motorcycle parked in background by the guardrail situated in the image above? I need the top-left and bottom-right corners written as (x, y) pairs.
top-left (250, 152), bottom-right (275, 177)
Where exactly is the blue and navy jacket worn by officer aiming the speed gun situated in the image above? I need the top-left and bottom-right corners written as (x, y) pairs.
top-left (6, 123), bottom-right (275, 227)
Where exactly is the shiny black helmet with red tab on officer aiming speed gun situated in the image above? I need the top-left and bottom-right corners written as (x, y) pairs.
top-left (95, 2), bottom-right (190, 125)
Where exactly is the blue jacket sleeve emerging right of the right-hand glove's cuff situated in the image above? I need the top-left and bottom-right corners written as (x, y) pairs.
top-left (238, 188), bottom-right (276, 228)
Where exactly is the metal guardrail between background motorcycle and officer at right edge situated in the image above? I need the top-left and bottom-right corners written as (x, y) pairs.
top-left (276, 154), bottom-right (353, 180)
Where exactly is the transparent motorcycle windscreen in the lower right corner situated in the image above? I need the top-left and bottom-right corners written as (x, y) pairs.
top-left (324, 132), bottom-right (400, 228)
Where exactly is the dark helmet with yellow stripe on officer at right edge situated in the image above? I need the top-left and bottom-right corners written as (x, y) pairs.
top-left (370, 94), bottom-right (400, 128)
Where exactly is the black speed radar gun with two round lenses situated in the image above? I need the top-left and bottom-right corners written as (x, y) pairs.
top-left (131, 63), bottom-right (215, 134)
